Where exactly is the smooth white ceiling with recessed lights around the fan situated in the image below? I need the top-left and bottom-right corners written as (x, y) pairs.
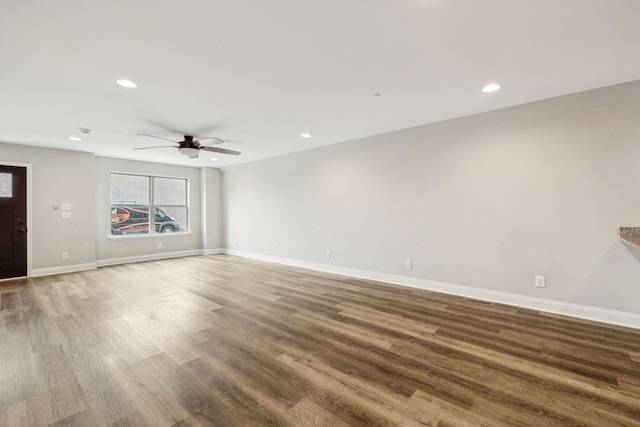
top-left (0, 0), bottom-right (640, 167)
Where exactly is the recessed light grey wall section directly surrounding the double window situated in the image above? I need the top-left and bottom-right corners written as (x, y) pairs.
top-left (94, 157), bottom-right (206, 265)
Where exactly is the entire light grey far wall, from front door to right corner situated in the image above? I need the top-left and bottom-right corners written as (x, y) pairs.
top-left (0, 143), bottom-right (222, 276)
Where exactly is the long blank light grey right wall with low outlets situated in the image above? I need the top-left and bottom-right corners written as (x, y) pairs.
top-left (223, 82), bottom-right (640, 313)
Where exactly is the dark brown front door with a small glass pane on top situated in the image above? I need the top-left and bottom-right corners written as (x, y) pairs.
top-left (0, 165), bottom-right (27, 279)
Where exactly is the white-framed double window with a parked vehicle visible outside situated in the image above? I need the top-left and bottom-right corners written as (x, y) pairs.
top-left (111, 172), bottom-right (189, 236)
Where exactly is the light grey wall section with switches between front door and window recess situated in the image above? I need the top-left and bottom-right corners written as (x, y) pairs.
top-left (0, 143), bottom-right (95, 275)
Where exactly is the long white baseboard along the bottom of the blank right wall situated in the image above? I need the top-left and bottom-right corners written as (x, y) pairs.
top-left (223, 249), bottom-right (640, 329)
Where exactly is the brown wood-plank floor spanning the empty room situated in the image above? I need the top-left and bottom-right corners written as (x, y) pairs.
top-left (0, 255), bottom-right (640, 427)
